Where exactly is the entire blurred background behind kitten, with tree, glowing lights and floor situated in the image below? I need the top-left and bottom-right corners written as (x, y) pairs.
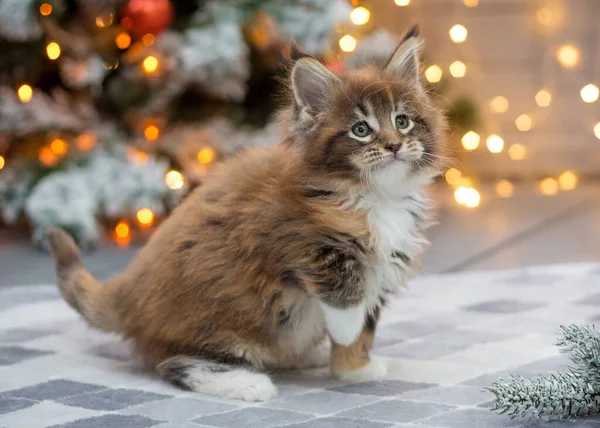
top-left (0, 0), bottom-right (600, 284)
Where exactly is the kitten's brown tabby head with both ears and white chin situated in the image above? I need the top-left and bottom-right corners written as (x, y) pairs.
top-left (290, 27), bottom-right (445, 192)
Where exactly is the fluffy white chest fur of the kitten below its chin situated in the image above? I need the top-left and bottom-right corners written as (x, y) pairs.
top-left (358, 192), bottom-right (428, 309)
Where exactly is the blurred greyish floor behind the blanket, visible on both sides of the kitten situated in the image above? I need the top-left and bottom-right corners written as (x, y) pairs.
top-left (0, 183), bottom-right (600, 286)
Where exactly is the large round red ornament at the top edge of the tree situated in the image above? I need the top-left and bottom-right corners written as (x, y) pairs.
top-left (121, 0), bottom-right (173, 39)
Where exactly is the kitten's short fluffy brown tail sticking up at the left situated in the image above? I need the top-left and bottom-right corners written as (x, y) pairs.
top-left (48, 228), bottom-right (120, 332)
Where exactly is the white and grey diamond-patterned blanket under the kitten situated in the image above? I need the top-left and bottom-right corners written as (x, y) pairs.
top-left (0, 264), bottom-right (600, 428)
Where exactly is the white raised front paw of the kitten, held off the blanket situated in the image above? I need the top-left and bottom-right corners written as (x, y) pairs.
top-left (320, 302), bottom-right (367, 346)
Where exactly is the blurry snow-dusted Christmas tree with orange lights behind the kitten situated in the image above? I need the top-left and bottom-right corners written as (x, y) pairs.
top-left (0, 0), bottom-right (478, 247)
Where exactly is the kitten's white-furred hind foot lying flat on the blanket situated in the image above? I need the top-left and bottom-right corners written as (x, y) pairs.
top-left (156, 356), bottom-right (277, 401)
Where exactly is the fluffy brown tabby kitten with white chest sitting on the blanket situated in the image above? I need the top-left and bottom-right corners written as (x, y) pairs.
top-left (49, 28), bottom-right (445, 401)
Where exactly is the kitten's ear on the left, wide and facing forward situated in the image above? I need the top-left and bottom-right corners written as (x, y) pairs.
top-left (292, 57), bottom-right (340, 115)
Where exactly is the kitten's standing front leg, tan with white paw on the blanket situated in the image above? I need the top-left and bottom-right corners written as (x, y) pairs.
top-left (330, 310), bottom-right (387, 381)
